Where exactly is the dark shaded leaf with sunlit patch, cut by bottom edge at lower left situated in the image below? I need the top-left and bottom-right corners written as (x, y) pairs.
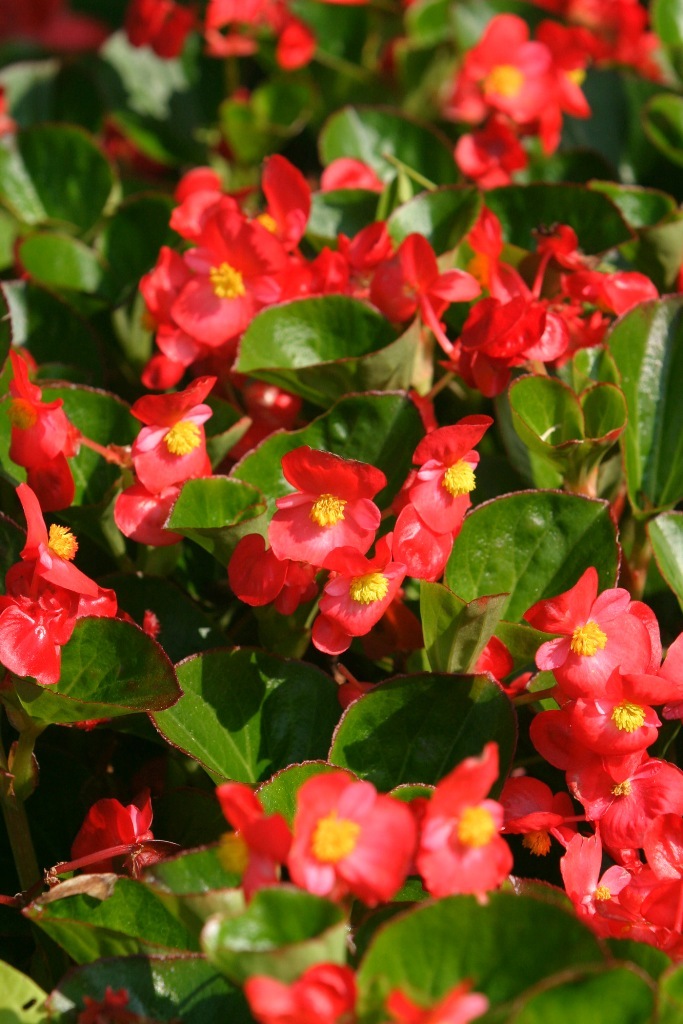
top-left (48, 955), bottom-right (245, 1024)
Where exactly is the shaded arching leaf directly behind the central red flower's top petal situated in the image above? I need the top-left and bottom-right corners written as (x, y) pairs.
top-left (232, 393), bottom-right (424, 520)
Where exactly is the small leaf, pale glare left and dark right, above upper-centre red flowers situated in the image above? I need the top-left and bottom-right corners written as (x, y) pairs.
top-left (387, 185), bottom-right (481, 249)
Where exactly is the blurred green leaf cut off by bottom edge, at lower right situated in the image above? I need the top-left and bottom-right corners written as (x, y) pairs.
top-left (508, 967), bottom-right (654, 1024)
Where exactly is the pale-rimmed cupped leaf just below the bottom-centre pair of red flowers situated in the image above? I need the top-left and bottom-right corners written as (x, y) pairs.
top-left (202, 886), bottom-right (348, 984)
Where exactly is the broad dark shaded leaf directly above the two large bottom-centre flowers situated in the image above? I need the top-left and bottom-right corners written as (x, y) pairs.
top-left (329, 674), bottom-right (516, 791)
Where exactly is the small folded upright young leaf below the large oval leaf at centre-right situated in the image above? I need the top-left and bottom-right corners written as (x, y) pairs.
top-left (420, 581), bottom-right (507, 672)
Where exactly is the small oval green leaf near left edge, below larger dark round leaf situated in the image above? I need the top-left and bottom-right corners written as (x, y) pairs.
top-left (18, 231), bottom-right (104, 295)
